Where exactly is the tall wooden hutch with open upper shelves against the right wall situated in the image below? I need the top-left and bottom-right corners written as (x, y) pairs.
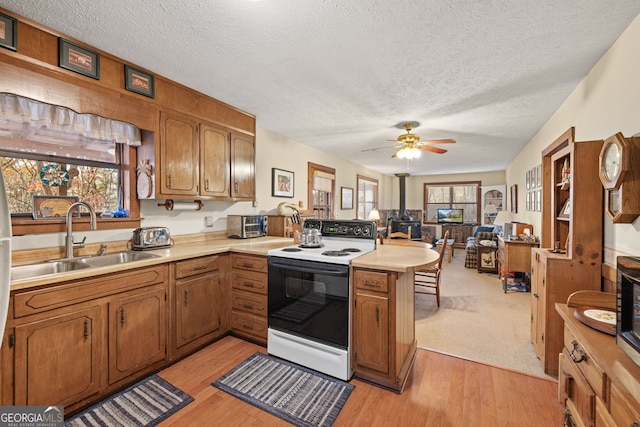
top-left (531, 128), bottom-right (603, 376)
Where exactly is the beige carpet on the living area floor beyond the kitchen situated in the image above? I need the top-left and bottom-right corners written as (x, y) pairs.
top-left (416, 249), bottom-right (548, 377)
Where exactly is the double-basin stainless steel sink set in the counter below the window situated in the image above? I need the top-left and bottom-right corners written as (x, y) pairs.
top-left (11, 251), bottom-right (160, 280)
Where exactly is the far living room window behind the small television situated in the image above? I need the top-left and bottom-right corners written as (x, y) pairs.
top-left (424, 181), bottom-right (481, 224)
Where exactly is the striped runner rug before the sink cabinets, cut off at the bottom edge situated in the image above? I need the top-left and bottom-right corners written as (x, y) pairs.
top-left (64, 375), bottom-right (193, 427)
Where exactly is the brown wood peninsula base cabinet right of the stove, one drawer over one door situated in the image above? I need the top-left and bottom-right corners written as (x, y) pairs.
top-left (351, 268), bottom-right (417, 392)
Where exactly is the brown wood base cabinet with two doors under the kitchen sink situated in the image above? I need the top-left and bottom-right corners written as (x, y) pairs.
top-left (7, 265), bottom-right (167, 411)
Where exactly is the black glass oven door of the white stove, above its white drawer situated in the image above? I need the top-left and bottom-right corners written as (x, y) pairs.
top-left (268, 256), bottom-right (349, 350)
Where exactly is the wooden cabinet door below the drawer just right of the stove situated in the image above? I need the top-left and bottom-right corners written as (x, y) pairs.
top-left (353, 293), bottom-right (389, 374)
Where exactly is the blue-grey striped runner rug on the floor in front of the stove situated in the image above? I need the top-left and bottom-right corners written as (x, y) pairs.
top-left (211, 353), bottom-right (355, 426)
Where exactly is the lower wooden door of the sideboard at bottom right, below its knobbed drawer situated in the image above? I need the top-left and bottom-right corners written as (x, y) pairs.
top-left (558, 348), bottom-right (596, 426)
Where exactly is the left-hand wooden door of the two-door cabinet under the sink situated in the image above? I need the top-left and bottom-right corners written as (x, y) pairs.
top-left (15, 306), bottom-right (106, 406)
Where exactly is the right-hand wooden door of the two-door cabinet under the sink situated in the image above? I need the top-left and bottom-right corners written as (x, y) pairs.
top-left (109, 285), bottom-right (166, 384)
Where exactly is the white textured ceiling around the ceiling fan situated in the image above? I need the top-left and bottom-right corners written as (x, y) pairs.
top-left (0, 0), bottom-right (640, 175)
